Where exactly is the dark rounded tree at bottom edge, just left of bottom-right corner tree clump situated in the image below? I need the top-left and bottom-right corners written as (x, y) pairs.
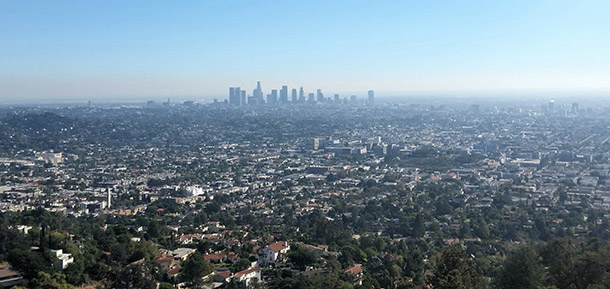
top-left (499, 247), bottom-right (544, 289)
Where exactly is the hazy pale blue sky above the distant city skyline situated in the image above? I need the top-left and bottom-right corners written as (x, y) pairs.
top-left (0, 0), bottom-right (610, 102)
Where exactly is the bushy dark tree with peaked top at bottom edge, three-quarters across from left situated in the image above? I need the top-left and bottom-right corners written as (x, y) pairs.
top-left (430, 245), bottom-right (484, 289)
